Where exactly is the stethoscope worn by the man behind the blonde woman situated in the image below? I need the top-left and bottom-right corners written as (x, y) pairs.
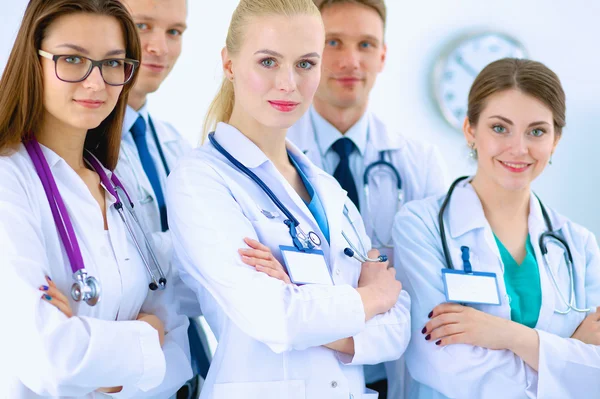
top-left (310, 115), bottom-right (404, 248)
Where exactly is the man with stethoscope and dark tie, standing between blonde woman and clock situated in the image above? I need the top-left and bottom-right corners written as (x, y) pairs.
top-left (288, 0), bottom-right (446, 399)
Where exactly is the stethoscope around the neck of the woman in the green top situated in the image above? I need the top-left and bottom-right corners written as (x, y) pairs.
top-left (438, 176), bottom-right (592, 315)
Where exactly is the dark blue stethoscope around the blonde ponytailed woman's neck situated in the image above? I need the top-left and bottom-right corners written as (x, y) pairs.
top-left (208, 132), bottom-right (387, 263)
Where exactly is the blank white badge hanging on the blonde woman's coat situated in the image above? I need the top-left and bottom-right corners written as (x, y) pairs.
top-left (279, 245), bottom-right (333, 285)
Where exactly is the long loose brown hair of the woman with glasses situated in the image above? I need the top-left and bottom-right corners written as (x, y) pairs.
top-left (0, 0), bottom-right (141, 170)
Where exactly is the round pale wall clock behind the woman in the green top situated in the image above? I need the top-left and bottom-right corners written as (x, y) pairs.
top-left (434, 32), bottom-right (527, 131)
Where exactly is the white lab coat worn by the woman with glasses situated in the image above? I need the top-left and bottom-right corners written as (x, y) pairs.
top-left (0, 145), bottom-right (191, 399)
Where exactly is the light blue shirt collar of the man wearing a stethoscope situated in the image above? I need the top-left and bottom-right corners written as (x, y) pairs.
top-left (309, 106), bottom-right (370, 156)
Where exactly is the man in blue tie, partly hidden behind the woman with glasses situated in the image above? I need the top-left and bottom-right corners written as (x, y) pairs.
top-left (117, 0), bottom-right (209, 398)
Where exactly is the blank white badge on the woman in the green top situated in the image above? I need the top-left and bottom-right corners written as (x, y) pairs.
top-left (442, 269), bottom-right (500, 305)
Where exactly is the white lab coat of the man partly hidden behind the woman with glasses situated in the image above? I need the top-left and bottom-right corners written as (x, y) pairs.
top-left (115, 105), bottom-right (202, 317)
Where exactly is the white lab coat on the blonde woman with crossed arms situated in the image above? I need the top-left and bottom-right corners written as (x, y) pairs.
top-left (168, 123), bottom-right (410, 399)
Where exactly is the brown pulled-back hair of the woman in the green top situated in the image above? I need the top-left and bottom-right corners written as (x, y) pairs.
top-left (467, 58), bottom-right (567, 136)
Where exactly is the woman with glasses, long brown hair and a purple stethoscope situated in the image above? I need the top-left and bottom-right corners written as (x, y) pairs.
top-left (0, 0), bottom-right (191, 398)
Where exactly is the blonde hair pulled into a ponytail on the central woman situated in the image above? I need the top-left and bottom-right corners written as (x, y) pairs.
top-left (202, 0), bottom-right (321, 140)
